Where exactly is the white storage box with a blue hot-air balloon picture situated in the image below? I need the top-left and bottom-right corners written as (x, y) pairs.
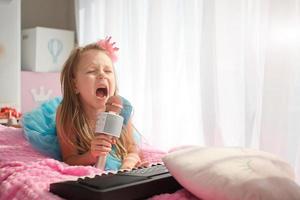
top-left (21, 27), bottom-right (74, 72)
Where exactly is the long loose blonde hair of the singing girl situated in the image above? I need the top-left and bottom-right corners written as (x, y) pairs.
top-left (59, 43), bottom-right (135, 159)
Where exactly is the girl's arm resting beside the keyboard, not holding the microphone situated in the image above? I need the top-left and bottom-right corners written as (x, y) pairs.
top-left (121, 121), bottom-right (140, 169)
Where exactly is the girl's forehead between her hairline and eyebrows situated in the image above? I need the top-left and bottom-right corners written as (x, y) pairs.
top-left (78, 49), bottom-right (112, 67)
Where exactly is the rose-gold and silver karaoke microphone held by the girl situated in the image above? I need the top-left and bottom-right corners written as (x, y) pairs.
top-left (95, 96), bottom-right (124, 170)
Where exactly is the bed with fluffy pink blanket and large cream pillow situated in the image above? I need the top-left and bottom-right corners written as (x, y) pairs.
top-left (0, 125), bottom-right (300, 200)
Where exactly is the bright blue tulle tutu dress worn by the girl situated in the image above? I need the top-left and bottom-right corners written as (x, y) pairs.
top-left (22, 97), bottom-right (138, 170)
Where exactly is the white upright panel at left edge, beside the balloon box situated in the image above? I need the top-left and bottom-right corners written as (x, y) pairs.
top-left (0, 0), bottom-right (21, 109)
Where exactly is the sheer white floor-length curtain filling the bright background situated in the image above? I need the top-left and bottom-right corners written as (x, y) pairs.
top-left (76, 0), bottom-right (300, 180)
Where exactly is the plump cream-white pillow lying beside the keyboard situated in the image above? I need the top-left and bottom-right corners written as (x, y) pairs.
top-left (163, 147), bottom-right (300, 200)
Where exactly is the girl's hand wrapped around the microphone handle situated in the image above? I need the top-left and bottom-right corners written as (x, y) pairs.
top-left (90, 134), bottom-right (116, 158)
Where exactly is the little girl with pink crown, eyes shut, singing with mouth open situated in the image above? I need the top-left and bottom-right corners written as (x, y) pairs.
top-left (23, 38), bottom-right (140, 170)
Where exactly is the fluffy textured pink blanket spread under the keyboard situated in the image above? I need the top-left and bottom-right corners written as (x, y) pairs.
top-left (0, 125), bottom-right (194, 200)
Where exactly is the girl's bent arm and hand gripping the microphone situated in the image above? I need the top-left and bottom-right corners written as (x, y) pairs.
top-left (56, 106), bottom-right (112, 165)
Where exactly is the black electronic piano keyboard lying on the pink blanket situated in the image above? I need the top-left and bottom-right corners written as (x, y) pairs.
top-left (50, 164), bottom-right (182, 200)
